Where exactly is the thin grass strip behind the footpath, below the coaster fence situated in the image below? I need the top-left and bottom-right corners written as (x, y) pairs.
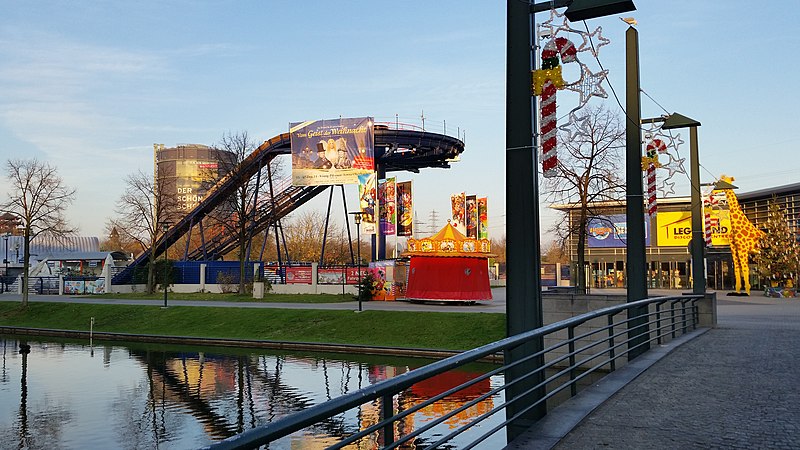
top-left (86, 291), bottom-right (356, 303)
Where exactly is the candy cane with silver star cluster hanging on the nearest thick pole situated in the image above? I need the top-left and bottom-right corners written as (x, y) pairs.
top-left (531, 9), bottom-right (611, 178)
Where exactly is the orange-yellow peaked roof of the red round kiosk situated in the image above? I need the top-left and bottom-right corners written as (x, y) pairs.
top-left (403, 220), bottom-right (496, 258)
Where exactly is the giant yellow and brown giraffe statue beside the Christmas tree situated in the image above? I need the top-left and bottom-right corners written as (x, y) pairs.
top-left (719, 175), bottom-right (765, 295)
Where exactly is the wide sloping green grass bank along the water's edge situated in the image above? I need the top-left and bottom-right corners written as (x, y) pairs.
top-left (0, 302), bottom-right (506, 350)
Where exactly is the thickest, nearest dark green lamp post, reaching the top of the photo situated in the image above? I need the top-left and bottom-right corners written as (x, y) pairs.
top-left (505, 0), bottom-right (636, 442)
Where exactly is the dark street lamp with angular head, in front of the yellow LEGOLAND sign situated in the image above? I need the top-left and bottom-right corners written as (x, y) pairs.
top-left (661, 113), bottom-right (706, 294)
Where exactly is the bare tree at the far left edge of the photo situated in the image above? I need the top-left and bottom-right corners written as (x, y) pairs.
top-left (0, 158), bottom-right (75, 307)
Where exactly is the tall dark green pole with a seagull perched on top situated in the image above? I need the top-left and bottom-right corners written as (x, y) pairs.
top-left (625, 27), bottom-right (650, 359)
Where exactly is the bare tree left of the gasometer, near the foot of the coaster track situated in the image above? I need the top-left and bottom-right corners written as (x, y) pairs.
top-left (106, 170), bottom-right (177, 294)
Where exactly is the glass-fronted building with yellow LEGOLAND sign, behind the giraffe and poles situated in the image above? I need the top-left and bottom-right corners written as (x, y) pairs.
top-left (551, 183), bottom-right (800, 290)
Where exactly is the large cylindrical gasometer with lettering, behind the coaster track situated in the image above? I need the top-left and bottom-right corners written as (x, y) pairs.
top-left (153, 144), bottom-right (236, 216)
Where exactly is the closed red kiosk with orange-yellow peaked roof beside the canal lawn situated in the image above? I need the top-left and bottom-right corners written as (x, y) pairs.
top-left (403, 220), bottom-right (494, 302)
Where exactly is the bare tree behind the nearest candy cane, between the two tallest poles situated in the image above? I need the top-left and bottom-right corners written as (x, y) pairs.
top-left (544, 107), bottom-right (625, 292)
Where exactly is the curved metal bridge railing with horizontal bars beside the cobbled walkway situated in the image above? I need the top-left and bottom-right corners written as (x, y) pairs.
top-left (203, 295), bottom-right (704, 449)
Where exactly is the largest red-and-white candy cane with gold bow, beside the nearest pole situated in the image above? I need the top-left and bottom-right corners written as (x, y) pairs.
top-left (533, 37), bottom-right (578, 178)
